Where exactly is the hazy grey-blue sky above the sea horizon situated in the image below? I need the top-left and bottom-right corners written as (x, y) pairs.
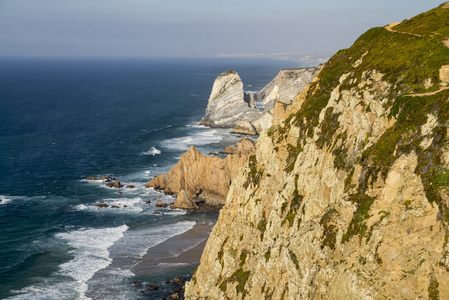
top-left (0, 0), bottom-right (444, 60)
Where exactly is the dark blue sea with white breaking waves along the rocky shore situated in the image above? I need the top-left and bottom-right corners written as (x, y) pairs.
top-left (0, 58), bottom-right (296, 299)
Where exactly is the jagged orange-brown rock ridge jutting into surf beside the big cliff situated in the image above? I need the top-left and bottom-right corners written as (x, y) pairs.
top-left (146, 138), bottom-right (255, 204)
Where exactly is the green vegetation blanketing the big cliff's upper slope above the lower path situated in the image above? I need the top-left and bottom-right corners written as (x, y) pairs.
top-left (271, 4), bottom-right (449, 179)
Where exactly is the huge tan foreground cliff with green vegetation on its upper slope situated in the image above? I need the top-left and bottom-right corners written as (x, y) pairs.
top-left (186, 3), bottom-right (449, 299)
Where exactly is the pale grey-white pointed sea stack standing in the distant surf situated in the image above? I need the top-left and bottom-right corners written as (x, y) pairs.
top-left (200, 70), bottom-right (260, 128)
